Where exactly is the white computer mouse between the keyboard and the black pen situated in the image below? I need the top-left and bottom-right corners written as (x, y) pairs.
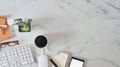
top-left (38, 55), bottom-right (48, 67)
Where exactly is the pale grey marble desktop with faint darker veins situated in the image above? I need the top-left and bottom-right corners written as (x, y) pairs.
top-left (0, 0), bottom-right (120, 67)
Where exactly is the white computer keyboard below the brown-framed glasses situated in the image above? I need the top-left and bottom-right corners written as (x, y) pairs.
top-left (0, 45), bottom-right (34, 67)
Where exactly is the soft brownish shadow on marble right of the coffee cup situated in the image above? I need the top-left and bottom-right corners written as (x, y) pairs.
top-left (45, 31), bottom-right (74, 48)
